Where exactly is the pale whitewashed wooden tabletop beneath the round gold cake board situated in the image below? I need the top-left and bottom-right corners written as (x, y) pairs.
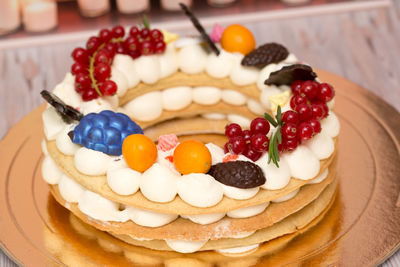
top-left (0, 1), bottom-right (400, 267)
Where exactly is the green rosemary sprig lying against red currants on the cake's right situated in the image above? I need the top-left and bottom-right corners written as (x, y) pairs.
top-left (264, 106), bottom-right (283, 168)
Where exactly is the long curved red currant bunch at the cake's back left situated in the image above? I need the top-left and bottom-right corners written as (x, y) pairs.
top-left (71, 25), bottom-right (166, 101)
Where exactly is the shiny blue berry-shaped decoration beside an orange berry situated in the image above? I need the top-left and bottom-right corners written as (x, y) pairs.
top-left (72, 110), bottom-right (143, 156)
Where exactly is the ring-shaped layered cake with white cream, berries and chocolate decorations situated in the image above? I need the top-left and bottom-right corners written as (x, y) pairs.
top-left (42, 4), bottom-right (340, 255)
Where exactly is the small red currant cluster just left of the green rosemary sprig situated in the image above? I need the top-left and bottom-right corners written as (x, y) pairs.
top-left (224, 118), bottom-right (270, 161)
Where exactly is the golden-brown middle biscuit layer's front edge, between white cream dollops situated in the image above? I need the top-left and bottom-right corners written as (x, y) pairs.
top-left (50, 155), bottom-right (337, 240)
